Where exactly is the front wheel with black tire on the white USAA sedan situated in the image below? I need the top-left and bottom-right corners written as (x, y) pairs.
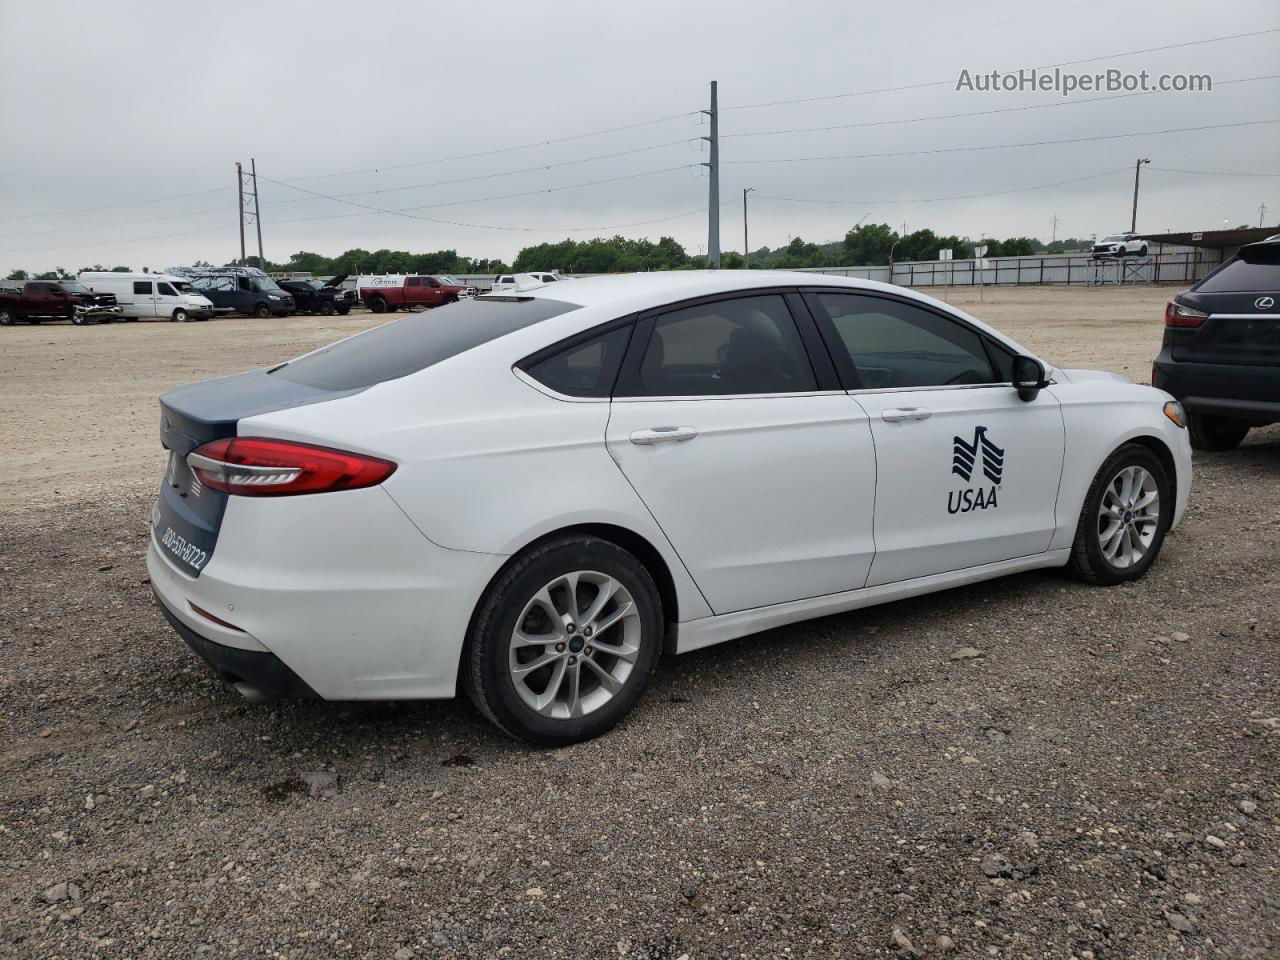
top-left (1068, 443), bottom-right (1174, 586)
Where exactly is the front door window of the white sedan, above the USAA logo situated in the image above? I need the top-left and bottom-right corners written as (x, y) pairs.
top-left (809, 293), bottom-right (1012, 390)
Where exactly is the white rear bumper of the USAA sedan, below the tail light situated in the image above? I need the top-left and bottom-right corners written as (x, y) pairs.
top-left (147, 486), bottom-right (506, 700)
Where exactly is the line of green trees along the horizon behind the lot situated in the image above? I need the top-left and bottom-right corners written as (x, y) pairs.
top-left (5, 223), bottom-right (1091, 280)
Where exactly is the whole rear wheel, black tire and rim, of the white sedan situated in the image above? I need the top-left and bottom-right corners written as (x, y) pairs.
top-left (462, 536), bottom-right (663, 746)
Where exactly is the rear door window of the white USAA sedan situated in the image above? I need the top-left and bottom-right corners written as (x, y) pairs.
top-left (625, 294), bottom-right (818, 397)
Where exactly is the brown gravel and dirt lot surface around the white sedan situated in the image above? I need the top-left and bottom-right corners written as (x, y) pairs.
top-left (0, 291), bottom-right (1280, 960)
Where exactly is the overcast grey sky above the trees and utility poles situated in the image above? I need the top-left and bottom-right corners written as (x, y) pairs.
top-left (0, 0), bottom-right (1280, 275)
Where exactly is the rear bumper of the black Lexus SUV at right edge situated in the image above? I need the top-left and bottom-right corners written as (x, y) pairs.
top-left (1152, 348), bottom-right (1280, 426)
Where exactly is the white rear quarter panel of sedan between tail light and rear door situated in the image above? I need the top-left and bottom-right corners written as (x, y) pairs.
top-left (239, 348), bottom-right (710, 620)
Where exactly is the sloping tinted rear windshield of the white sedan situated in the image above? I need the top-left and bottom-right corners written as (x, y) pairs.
top-left (269, 297), bottom-right (579, 390)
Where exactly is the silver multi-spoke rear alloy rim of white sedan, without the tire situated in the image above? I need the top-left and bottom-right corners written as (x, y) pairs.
top-left (508, 570), bottom-right (643, 719)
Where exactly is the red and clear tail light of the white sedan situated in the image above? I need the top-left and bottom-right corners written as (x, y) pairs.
top-left (187, 436), bottom-right (396, 497)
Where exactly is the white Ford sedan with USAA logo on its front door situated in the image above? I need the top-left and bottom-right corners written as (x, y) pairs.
top-left (147, 271), bottom-right (1192, 745)
